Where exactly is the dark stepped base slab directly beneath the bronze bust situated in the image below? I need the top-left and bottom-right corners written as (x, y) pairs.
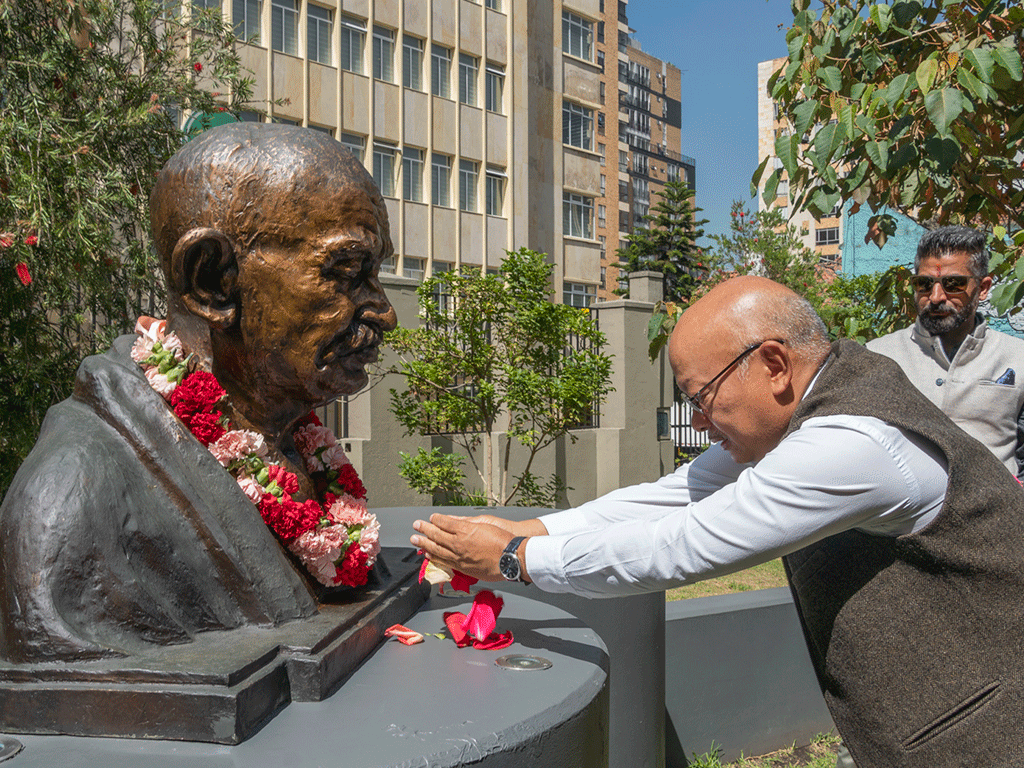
top-left (0, 548), bottom-right (428, 744)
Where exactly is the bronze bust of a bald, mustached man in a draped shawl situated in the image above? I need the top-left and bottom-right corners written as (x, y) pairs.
top-left (0, 123), bottom-right (395, 663)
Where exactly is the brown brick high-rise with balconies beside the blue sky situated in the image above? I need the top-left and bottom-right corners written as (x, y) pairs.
top-left (596, 0), bottom-right (696, 299)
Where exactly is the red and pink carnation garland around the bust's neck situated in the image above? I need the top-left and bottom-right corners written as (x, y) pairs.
top-left (131, 317), bottom-right (380, 587)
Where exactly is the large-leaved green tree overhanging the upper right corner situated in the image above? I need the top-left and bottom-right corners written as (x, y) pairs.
top-left (754, 0), bottom-right (1024, 310)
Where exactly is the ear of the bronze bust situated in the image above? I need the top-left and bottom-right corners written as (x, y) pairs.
top-left (171, 227), bottom-right (239, 329)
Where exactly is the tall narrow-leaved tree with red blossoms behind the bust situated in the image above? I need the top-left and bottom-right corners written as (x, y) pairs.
top-left (0, 0), bottom-right (251, 493)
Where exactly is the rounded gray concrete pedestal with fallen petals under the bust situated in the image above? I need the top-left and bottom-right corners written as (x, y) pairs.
top-left (2, 589), bottom-right (608, 768)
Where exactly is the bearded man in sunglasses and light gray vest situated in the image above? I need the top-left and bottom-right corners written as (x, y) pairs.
top-left (867, 226), bottom-right (1024, 479)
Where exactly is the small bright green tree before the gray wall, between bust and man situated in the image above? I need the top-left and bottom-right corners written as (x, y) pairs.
top-left (386, 249), bottom-right (611, 506)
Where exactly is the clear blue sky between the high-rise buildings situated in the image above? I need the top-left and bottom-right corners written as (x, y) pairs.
top-left (628, 0), bottom-right (793, 243)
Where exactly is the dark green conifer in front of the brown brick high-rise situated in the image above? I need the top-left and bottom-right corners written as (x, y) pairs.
top-left (615, 181), bottom-right (708, 300)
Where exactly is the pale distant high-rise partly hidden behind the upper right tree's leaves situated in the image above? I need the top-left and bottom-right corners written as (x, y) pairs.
top-left (758, 57), bottom-right (843, 269)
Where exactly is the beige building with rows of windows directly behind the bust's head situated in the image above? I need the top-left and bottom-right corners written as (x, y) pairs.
top-left (193, 0), bottom-right (602, 297)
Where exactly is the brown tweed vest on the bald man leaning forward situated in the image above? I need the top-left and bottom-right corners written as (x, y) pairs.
top-left (785, 341), bottom-right (1024, 768)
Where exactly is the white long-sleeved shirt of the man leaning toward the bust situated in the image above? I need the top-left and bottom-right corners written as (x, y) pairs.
top-left (525, 416), bottom-right (948, 597)
